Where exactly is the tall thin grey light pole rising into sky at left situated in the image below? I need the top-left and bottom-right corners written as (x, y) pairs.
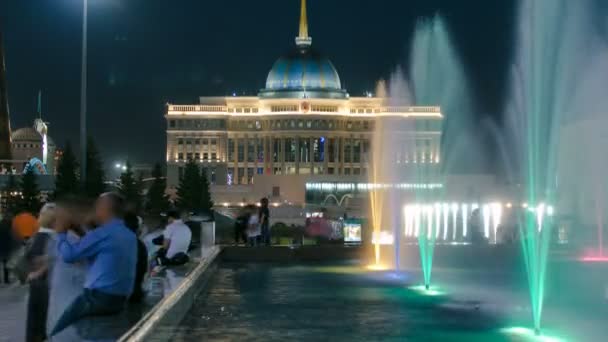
top-left (80, 0), bottom-right (88, 184)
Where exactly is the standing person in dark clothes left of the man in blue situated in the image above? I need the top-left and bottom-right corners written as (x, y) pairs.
top-left (25, 203), bottom-right (55, 342)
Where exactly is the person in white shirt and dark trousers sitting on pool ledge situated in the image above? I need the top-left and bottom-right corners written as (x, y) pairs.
top-left (154, 210), bottom-right (192, 266)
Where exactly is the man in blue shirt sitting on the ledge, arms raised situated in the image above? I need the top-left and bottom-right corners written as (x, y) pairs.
top-left (51, 193), bottom-right (137, 336)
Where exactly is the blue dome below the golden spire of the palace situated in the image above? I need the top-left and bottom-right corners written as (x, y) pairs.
top-left (260, 46), bottom-right (346, 97)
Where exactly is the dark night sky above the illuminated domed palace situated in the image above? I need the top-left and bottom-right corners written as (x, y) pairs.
top-left (0, 0), bottom-right (516, 166)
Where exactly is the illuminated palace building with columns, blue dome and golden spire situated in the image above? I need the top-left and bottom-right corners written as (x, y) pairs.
top-left (165, 1), bottom-right (443, 203)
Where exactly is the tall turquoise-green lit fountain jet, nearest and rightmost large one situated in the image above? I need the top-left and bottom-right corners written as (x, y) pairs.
top-left (504, 0), bottom-right (590, 334)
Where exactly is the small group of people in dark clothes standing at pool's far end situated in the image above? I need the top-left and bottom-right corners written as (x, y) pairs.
top-left (234, 198), bottom-right (271, 247)
